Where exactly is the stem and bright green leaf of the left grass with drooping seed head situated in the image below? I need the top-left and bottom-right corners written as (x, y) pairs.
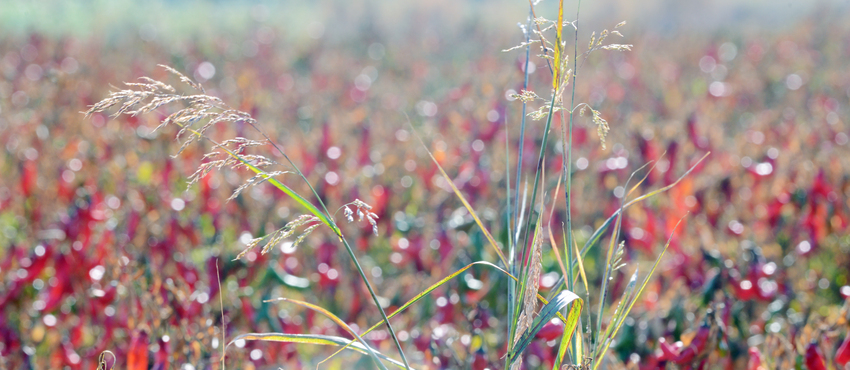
top-left (181, 126), bottom-right (410, 369)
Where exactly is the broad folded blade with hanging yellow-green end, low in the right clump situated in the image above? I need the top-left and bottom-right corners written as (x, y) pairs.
top-left (507, 290), bottom-right (583, 364)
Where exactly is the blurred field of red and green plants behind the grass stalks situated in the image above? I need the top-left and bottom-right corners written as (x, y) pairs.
top-left (0, 1), bottom-right (850, 370)
